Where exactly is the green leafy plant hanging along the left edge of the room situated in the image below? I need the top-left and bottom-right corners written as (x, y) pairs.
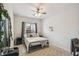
top-left (0, 3), bottom-right (12, 48)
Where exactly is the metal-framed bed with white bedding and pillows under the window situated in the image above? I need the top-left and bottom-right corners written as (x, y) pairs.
top-left (24, 33), bottom-right (48, 52)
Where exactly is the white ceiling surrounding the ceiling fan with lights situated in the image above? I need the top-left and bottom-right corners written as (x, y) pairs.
top-left (12, 3), bottom-right (79, 19)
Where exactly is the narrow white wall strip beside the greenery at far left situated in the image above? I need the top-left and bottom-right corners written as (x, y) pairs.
top-left (4, 3), bottom-right (14, 47)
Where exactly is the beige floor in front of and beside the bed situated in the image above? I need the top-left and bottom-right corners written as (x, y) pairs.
top-left (14, 45), bottom-right (71, 56)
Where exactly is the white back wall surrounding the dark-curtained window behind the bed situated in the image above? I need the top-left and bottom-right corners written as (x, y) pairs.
top-left (14, 16), bottom-right (42, 39)
